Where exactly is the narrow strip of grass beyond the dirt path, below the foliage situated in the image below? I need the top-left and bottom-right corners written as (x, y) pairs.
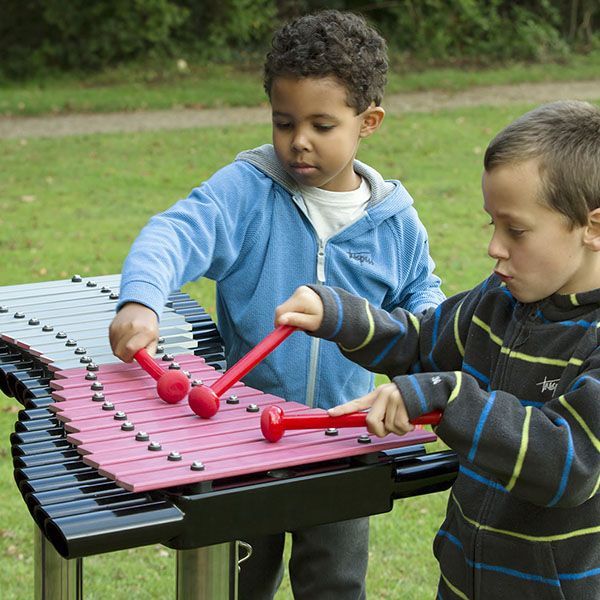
top-left (0, 50), bottom-right (600, 116)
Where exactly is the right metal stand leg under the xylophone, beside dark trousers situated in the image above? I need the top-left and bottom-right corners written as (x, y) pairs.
top-left (177, 542), bottom-right (238, 600)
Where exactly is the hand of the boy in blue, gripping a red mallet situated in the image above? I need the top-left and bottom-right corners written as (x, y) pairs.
top-left (108, 302), bottom-right (158, 362)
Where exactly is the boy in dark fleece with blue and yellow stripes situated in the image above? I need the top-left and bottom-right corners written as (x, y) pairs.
top-left (276, 102), bottom-right (600, 600)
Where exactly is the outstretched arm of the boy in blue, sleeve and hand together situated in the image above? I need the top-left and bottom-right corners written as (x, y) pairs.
top-left (109, 162), bottom-right (262, 362)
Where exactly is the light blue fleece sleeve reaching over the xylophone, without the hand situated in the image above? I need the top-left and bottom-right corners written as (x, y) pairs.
top-left (117, 163), bottom-right (258, 316)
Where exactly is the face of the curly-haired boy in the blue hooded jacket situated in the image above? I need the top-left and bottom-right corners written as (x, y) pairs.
top-left (271, 77), bottom-right (383, 192)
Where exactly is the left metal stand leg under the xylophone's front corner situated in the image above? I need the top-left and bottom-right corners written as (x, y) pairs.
top-left (33, 524), bottom-right (83, 600)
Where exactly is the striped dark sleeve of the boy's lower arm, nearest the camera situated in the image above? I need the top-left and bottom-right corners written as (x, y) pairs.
top-left (394, 350), bottom-right (600, 507)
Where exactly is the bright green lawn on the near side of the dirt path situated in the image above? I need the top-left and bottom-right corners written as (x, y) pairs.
top-left (0, 101), bottom-right (596, 600)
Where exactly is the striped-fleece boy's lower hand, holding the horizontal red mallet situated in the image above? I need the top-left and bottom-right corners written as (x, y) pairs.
top-left (327, 383), bottom-right (415, 437)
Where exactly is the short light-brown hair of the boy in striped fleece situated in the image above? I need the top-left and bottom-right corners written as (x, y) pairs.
top-left (484, 100), bottom-right (600, 226)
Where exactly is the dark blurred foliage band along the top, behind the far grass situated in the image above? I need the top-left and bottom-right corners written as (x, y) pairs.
top-left (0, 0), bottom-right (600, 79)
